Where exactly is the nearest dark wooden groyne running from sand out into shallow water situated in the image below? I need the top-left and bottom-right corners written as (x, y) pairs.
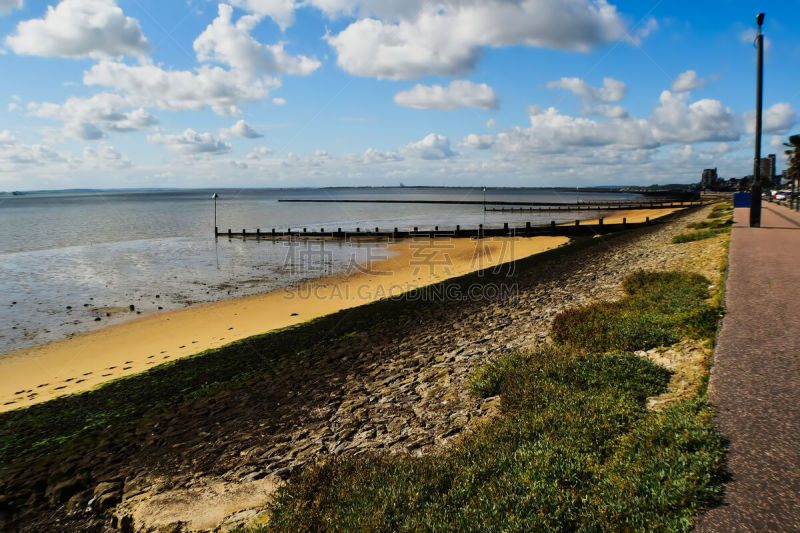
top-left (215, 216), bottom-right (668, 240)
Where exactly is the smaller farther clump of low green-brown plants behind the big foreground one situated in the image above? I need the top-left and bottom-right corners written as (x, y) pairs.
top-left (553, 272), bottom-right (716, 353)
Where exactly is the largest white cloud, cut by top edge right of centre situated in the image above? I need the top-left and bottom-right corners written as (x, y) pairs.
top-left (324, 0), bottom-right (628, 80)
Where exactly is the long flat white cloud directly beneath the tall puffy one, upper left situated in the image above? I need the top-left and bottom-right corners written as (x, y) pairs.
top-left (83, 61), bottom-right (280, 116)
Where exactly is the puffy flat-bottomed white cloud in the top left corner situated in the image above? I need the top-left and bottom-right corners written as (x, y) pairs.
top-left (6, 0), bottom-right (152, 58)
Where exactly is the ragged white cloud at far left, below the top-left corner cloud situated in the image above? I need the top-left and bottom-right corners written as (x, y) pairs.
top-left (28, 93), bottom-right (158, 140)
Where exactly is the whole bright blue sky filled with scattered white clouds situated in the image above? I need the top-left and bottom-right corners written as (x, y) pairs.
top-left (0, 0), bottom-right (800, 191)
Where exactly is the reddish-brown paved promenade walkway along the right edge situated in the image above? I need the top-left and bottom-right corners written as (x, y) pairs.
top-left (697, 203), bottom-right (800, 533)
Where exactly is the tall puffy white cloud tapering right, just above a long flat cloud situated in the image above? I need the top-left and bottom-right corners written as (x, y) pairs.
top-left (194, 4), bottom-right (320, 76)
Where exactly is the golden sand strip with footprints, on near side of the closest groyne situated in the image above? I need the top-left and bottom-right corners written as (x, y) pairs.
top-left (0, 235), bottom-right (568, 411)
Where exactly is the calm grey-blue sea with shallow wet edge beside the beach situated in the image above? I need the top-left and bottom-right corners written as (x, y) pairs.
top-left (0, 188), bottom-right (634, 353)
